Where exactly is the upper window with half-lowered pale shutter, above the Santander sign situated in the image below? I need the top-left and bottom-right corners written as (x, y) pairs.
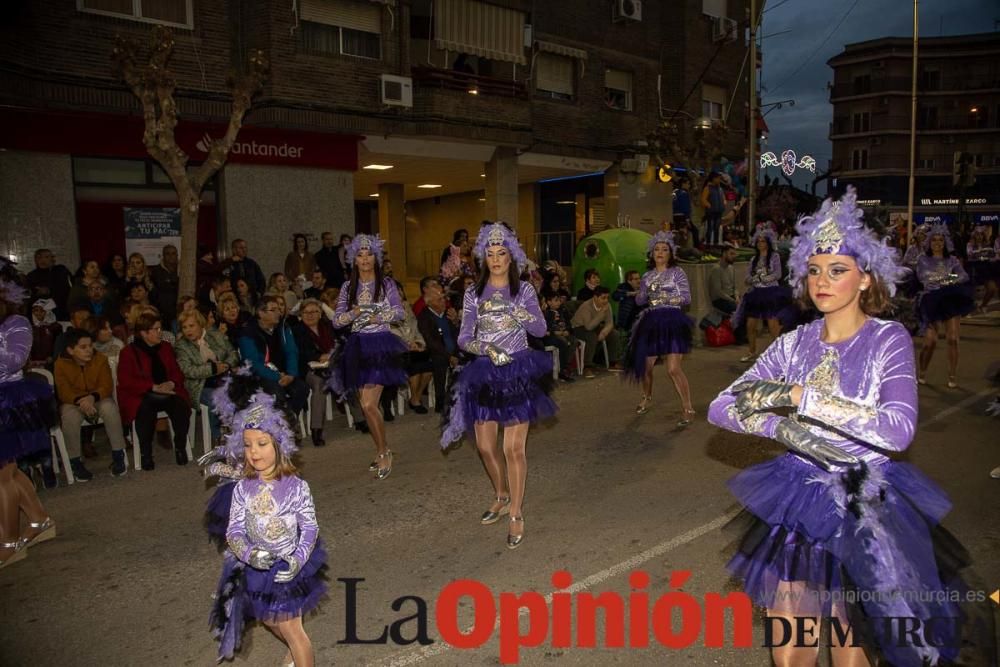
top-left (299, 0), bottom-right (382, 60)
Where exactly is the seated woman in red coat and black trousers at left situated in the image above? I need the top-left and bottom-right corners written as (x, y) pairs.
top-left (118, 309), bottom-right (191, 470)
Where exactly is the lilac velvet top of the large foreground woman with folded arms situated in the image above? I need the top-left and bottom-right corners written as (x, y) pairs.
top-left (708, 318), bottom-right (917, 464)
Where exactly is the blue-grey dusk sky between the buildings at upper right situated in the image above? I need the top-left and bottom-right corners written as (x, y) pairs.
top-left (759, 0), bottom-right (1000, 192)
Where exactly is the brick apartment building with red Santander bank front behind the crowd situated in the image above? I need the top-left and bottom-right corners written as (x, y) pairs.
top-left (0, 0), bottom-right (746, 277)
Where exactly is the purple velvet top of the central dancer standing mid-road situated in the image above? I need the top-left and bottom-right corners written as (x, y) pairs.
top-left (458, 282), bottom-right (545, 354)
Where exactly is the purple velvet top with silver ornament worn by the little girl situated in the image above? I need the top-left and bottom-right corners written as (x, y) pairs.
top-left (226, 475), bottom-right (319, 565)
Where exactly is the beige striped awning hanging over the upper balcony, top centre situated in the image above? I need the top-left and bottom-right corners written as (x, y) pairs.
top-left (432, 0), bottom-right (527, 65)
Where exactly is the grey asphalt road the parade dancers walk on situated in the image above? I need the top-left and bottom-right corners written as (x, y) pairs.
top-left (0, 326), bottom-right (1000, 667)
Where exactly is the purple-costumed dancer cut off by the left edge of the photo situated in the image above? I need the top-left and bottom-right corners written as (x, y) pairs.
top-left (0, 257), bottom-right (56, 568)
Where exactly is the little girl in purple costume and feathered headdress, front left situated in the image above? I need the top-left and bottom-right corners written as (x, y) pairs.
top-left (211, 391), bottom-right (326, 667)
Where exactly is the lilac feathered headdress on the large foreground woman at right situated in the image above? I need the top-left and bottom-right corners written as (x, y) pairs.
top-left (788, 186), bottom-right (903, 296)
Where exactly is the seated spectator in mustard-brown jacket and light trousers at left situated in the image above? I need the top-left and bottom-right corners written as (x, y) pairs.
top-left (55, 329), bottom-right (125, 482)
